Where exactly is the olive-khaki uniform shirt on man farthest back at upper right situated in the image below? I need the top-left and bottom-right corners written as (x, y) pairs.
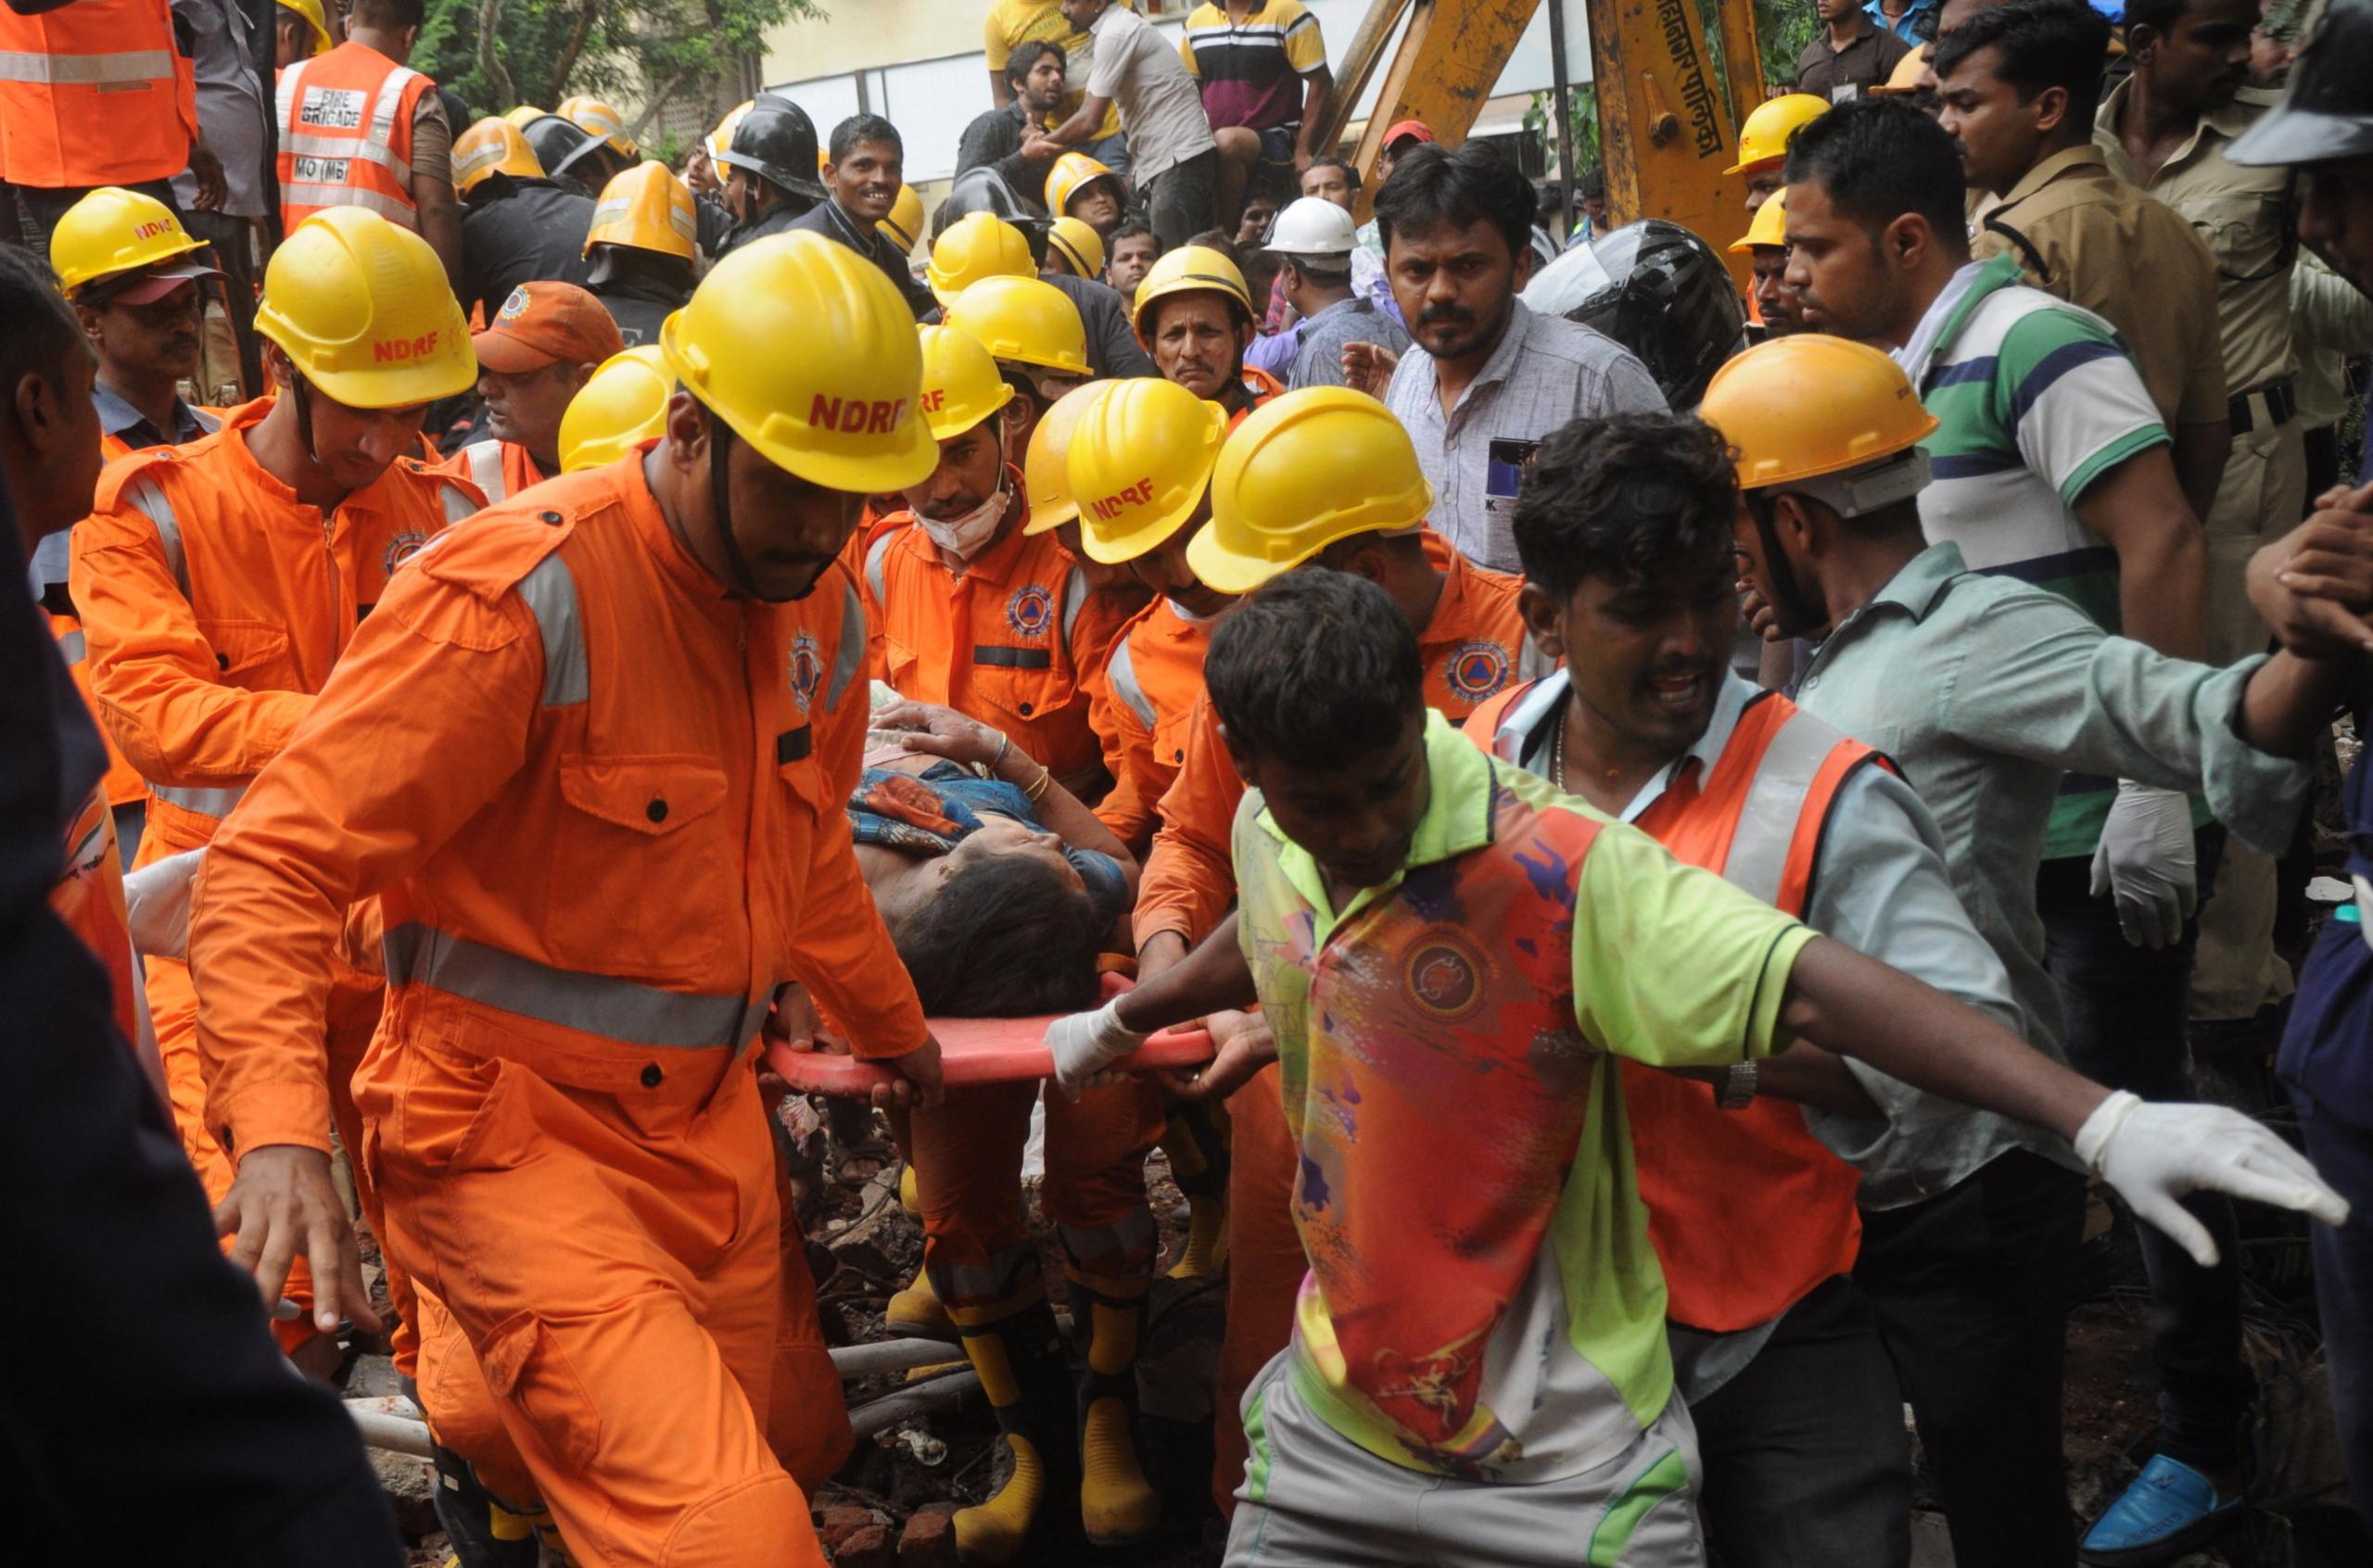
top-left (2093, 78), bottom-right (2297, 396)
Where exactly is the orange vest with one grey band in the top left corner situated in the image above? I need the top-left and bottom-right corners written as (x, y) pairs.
top-left (0, 0), bottom-right (197, 190)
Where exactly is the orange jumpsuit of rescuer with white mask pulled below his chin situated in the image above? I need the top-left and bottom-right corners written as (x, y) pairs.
top-left (866, 467), bottom-right (1103, 795)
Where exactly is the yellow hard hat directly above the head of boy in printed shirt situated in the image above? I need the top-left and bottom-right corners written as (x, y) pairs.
top-left (1186, 386), bottom-right (1433, 593)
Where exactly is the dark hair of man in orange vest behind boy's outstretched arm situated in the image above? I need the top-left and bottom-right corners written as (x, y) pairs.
top-left (1514, 412), bottom-right (1739, 601)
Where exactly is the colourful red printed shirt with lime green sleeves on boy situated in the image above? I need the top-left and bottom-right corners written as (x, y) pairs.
top-left (1234, 714), bottom-right (1813, 1483)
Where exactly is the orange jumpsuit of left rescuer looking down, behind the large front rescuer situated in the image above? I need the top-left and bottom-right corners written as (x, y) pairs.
top-left (69, 398), bottom-right (479, 1361)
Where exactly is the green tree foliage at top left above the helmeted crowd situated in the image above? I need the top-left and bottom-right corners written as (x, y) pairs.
top-left (412, 0), bottom-right (826, 114)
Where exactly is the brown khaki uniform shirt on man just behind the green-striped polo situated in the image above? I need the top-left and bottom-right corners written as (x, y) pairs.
top-left (1970, 145), bottom-right (2226, 429)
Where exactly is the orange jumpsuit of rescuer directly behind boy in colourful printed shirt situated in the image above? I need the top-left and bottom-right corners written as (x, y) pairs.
top-left (1186, 534), bottom-right (1538, 1516)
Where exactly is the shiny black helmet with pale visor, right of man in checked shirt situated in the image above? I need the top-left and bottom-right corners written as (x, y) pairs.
top-left (1524, 218), bottom-right (1746, 408)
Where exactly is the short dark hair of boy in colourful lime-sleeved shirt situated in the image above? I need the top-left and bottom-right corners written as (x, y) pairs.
top-left (1203, 567), bottom-right (1427, 768)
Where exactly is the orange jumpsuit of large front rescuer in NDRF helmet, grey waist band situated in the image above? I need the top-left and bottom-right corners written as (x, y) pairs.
top-left (192, 453), bottom-right (925, 1568)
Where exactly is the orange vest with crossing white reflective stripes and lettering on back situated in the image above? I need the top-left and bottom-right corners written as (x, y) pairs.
top-left (280, 41), bottom-right (437, 233)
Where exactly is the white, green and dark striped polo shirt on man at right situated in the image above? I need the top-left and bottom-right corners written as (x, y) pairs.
top-left (1896, 254), bottom-right (2169, 859)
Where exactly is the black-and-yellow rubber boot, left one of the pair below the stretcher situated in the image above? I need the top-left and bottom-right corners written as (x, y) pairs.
top-left (954, 1296), bottom-right (1080, 1563)
